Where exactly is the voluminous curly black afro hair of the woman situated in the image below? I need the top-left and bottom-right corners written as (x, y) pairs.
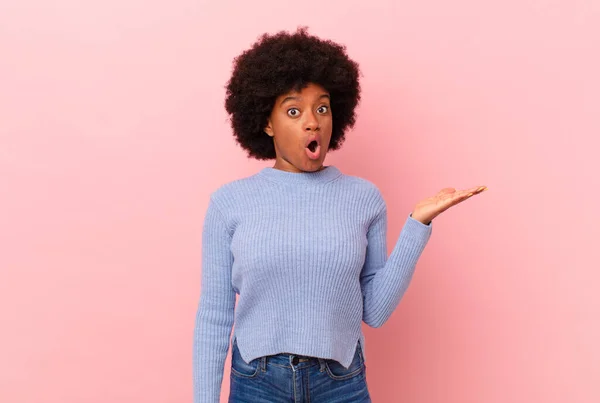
top-left (225, 27), bottom-right (360, 160)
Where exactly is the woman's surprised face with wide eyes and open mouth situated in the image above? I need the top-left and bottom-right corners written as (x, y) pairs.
top-left (265, 83), bottom-right (332, 172)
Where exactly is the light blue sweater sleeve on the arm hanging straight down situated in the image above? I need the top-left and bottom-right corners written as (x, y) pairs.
top-left (193, 198), bottom-right (235, 403)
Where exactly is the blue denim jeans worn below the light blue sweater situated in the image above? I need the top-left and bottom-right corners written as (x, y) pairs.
top-left (229, 339), bottom-right (371, 403)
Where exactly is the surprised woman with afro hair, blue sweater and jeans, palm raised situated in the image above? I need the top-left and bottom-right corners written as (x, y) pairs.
top-left (194, 28), bottom-right (485, 403)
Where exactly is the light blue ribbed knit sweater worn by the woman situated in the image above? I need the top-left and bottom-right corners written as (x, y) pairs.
top-left (193, 165), bottom-right (432, 403)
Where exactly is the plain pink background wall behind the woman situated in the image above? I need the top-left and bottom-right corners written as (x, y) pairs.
top-left (0, 0), bottom-right (600, 403)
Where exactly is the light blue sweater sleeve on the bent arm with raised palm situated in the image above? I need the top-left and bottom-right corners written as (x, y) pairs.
top-left (360, 196), bottom-right (432, 327)
